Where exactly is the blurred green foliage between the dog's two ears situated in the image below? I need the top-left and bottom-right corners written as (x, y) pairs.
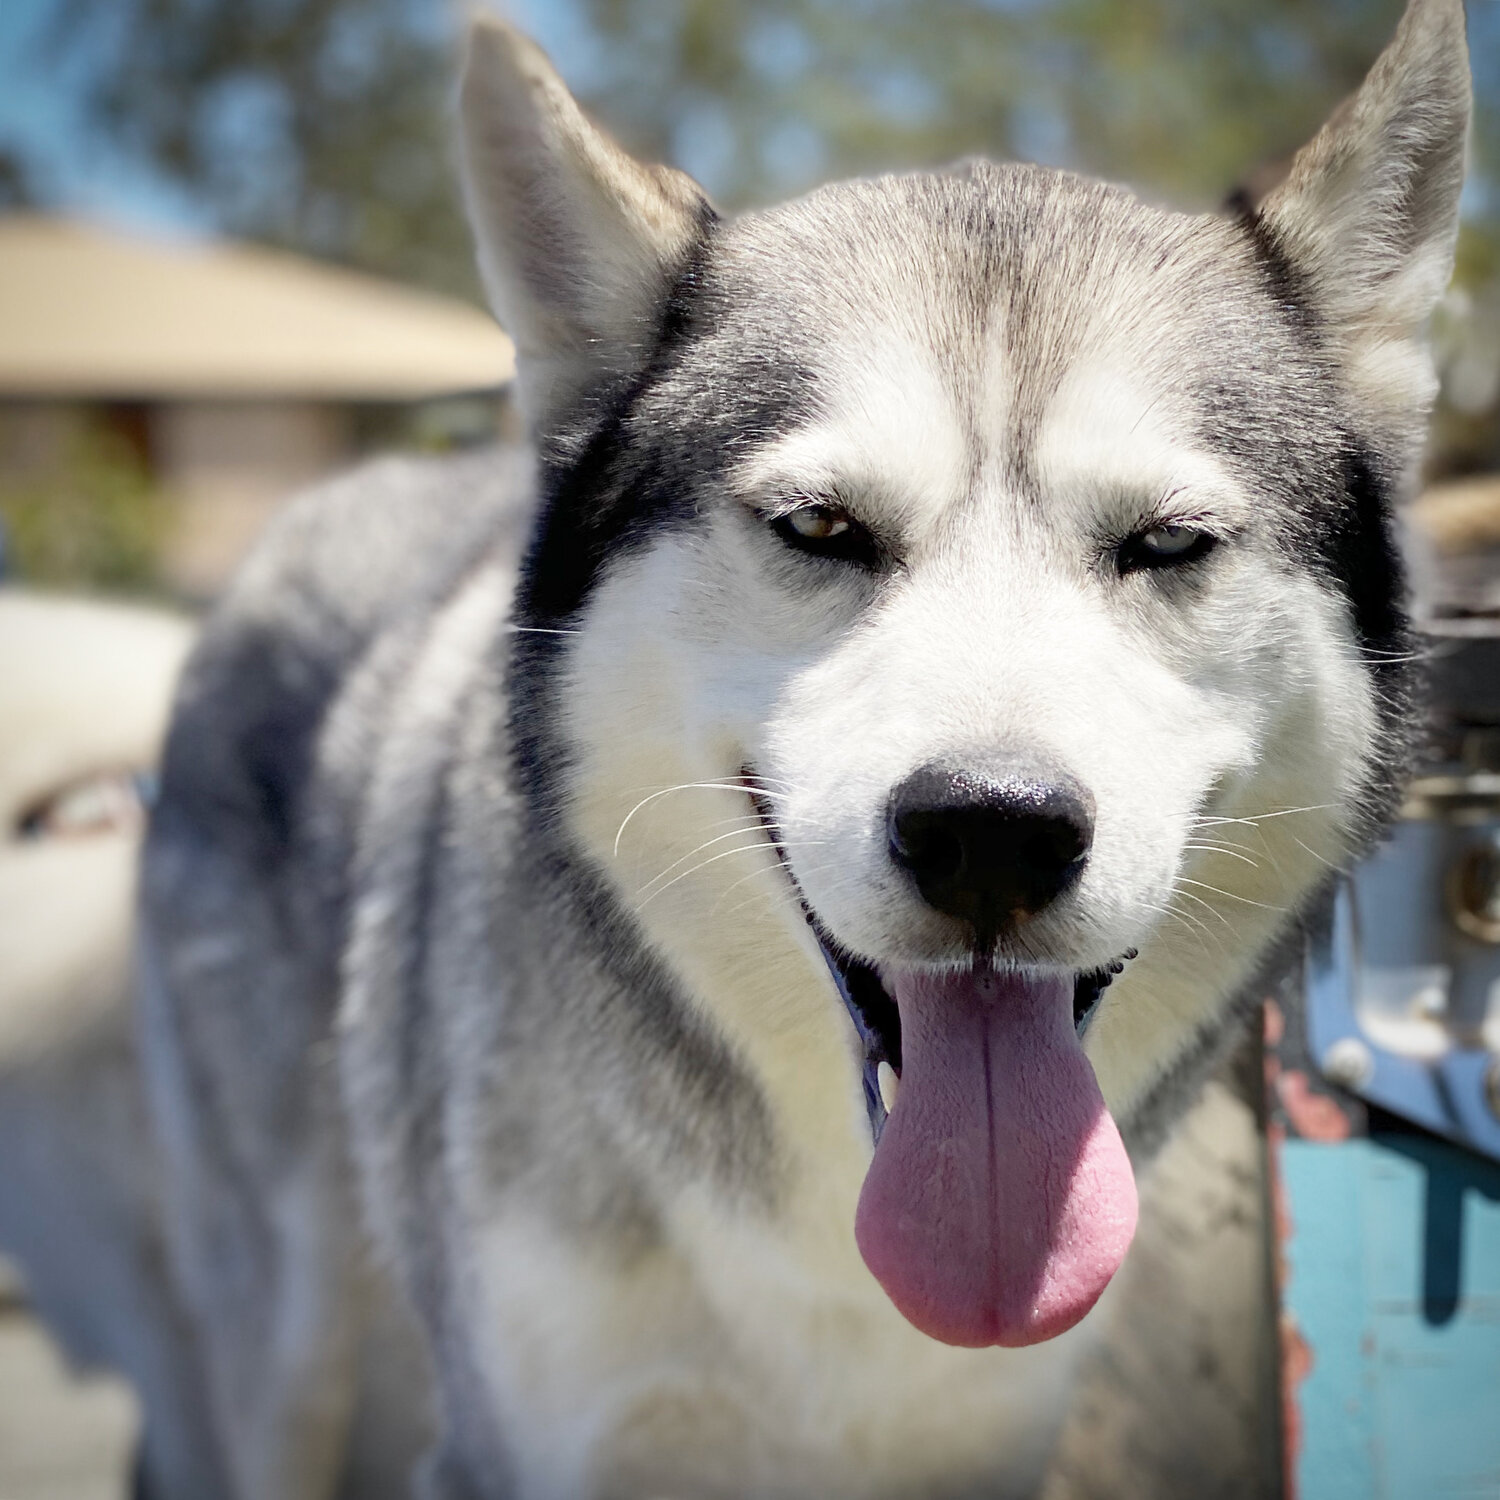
top-left (564, 0), bottom-right (1401, 204)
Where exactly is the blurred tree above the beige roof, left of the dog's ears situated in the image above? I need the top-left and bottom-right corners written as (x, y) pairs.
top-left (53, 0), bottom-right (477, 294)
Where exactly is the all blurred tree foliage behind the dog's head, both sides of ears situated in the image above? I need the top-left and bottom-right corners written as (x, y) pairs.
top-left (29, 0), bottom-right (1500, 464)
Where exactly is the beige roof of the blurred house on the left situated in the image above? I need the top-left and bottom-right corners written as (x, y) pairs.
top-left (0, 215), bottom-right (515, 401)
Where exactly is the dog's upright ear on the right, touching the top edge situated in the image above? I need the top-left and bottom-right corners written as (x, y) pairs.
top-left (1260, 0), bottom-right (1470, 464)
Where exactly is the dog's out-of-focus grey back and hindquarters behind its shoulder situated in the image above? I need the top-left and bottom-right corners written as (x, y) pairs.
top-left (140, 455), bottom-right (528, 1494)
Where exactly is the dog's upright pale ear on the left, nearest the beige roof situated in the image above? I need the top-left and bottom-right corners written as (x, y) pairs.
top-left (459, 17), bottom-right (713, 434)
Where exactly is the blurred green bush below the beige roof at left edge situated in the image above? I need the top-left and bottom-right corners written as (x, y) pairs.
top-left (0, 426), bottom-right (170, 594)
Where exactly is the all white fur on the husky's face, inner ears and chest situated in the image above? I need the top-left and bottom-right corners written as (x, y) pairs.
top-left (429, 0), bottom-right (1463, 1500)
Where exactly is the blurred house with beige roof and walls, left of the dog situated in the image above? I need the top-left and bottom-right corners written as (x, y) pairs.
top-left (0, 215), bottom-right (515, 597)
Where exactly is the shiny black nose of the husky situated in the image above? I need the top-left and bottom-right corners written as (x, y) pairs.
top-left (887, 765), bottom-right (1094, 935)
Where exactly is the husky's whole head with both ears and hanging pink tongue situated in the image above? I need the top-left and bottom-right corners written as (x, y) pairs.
top-left (465, 0), bottom-right (1467, 1344)
